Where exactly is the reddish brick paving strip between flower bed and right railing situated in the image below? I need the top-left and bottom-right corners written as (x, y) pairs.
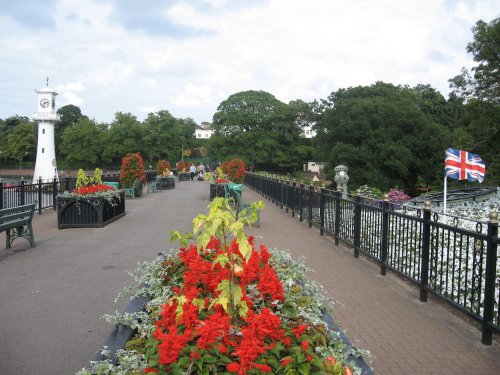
top-left (243, 188), bottom-right (500, 375)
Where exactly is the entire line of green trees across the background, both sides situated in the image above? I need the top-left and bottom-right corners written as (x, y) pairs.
top-left (0, 18), bottom-right (500, 194)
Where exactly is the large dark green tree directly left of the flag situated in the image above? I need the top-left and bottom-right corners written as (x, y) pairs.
top-left (316, 82), bottom-right (447, 193)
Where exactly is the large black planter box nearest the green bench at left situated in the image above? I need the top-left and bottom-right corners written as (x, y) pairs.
top-left (57, 191), bottom-right (125, 229)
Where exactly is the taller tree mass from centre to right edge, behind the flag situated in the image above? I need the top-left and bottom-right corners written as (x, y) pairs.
top-left (209, 18), bottom-right (500, 194)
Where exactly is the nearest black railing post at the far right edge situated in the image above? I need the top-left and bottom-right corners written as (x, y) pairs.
top-left (481, 211), bottom-right (498, 345)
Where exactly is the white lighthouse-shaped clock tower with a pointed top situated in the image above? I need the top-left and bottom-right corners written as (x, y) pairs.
top-left (33, 77), bottom-right (60, 183)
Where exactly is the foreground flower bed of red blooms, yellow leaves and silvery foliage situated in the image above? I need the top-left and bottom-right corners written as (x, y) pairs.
top-left (80, 198), bottom-right (372, 374)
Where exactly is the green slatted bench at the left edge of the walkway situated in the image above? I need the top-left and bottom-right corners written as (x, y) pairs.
top-left (0, 201), bottom-right (38, 249)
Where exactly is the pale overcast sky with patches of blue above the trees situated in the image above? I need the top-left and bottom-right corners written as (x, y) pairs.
top-left (0, 0), bottom-right (500, 123)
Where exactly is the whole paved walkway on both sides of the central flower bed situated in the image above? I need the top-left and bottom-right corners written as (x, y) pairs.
top-left (0, 182), bottom-right (500, 375)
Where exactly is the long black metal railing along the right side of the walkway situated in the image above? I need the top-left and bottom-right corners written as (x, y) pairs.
top-left (245, 173), bottom-right (500, 345)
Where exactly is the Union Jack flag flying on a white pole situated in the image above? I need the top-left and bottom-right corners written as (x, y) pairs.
top-left (444, 148), bottom-right (486, 182)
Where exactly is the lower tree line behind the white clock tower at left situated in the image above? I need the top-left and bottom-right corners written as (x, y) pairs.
top-left (0, 105), bottom-right (206, 168)
